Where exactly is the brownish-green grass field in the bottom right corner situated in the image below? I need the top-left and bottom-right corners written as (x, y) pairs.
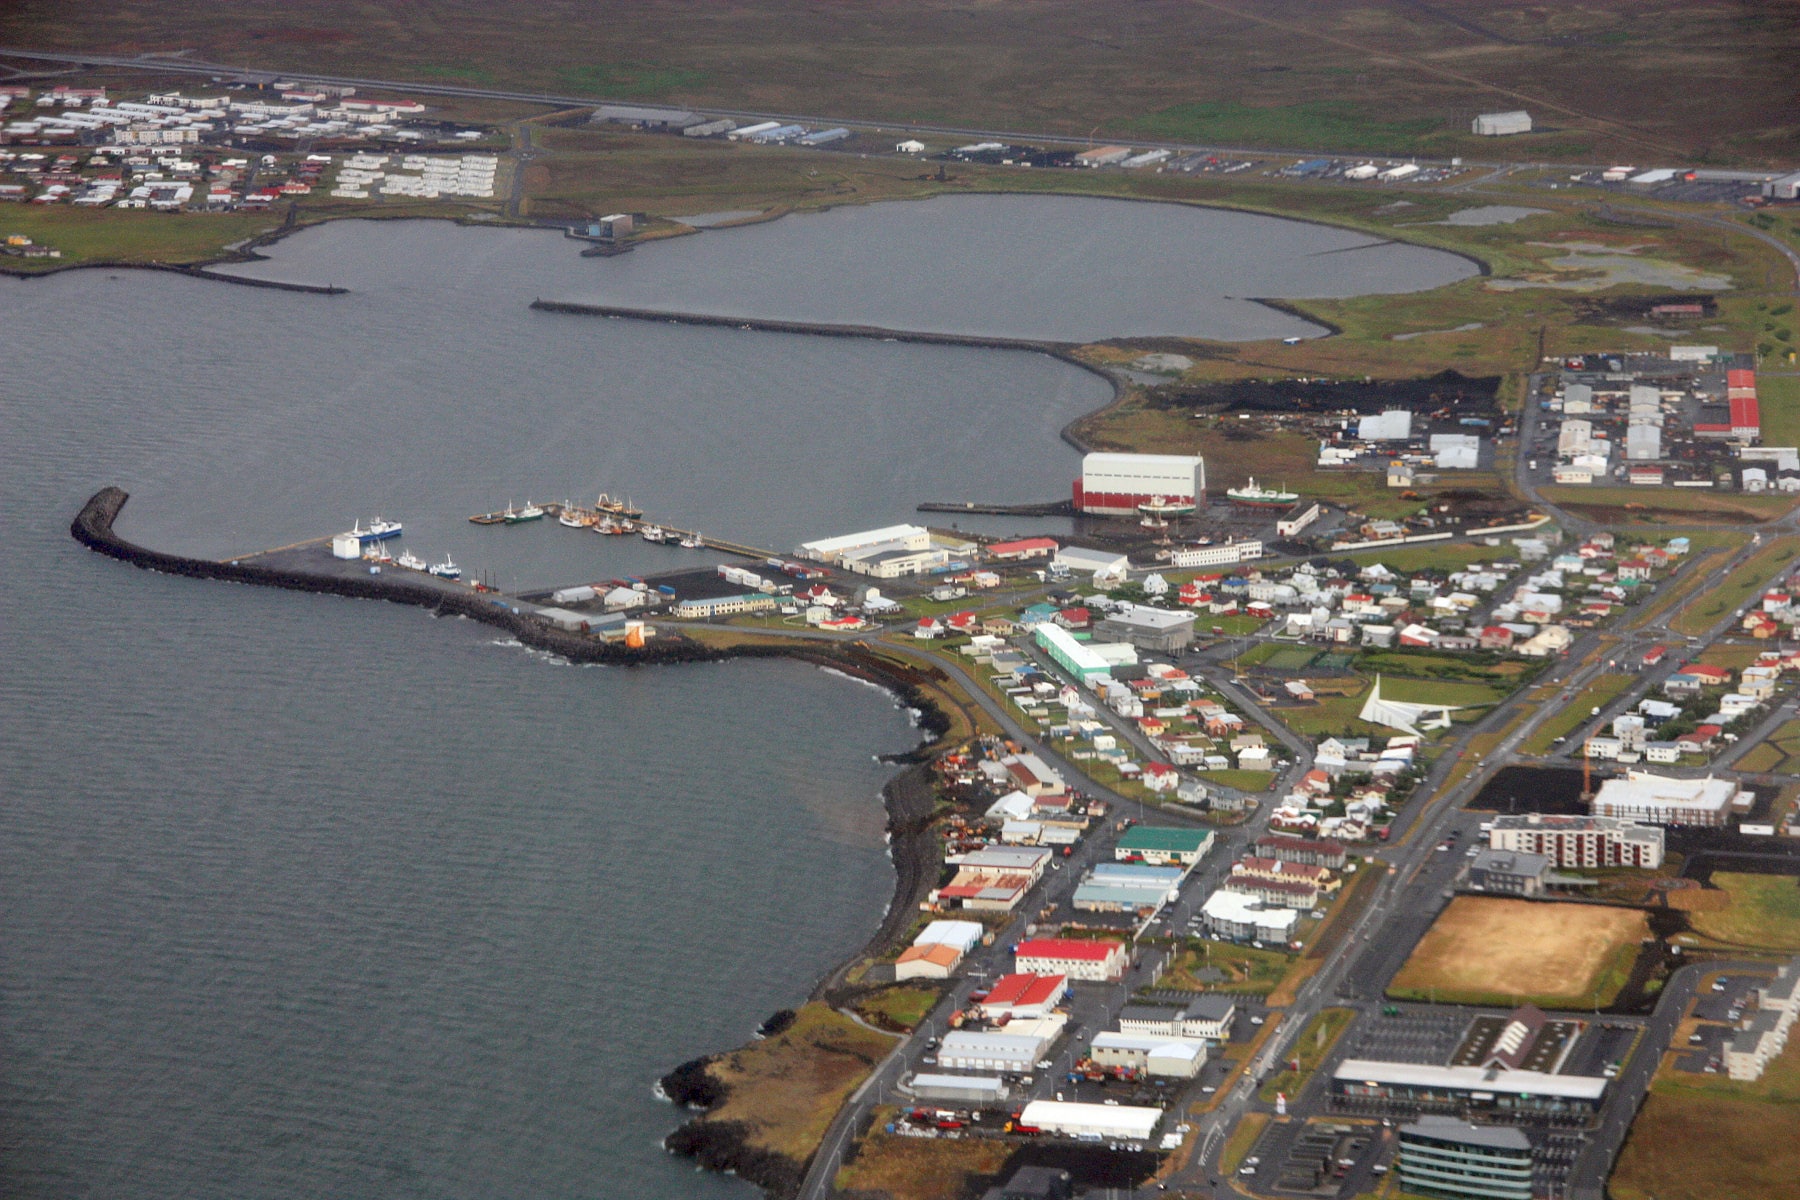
top-left (1607, 1038), bottom-right (1800, 1200)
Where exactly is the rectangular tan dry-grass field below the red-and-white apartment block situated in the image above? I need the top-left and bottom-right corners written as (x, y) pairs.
top-left (1388, 896), bottom-right (1649, 1007)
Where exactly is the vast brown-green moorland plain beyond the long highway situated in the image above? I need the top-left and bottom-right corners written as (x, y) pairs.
top-left (14, 0), bottom-right (1800, 162)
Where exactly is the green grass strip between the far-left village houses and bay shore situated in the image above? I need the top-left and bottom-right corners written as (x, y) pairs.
top-left (0, 205), bottom-right (281, 272)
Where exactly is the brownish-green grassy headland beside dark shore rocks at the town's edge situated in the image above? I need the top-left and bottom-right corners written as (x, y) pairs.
top-left (706, 1002), bottom-right (895, 1162)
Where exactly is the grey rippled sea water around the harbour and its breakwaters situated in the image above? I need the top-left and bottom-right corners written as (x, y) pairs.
top-left (0, 201), bottom-right (1456, 1198)
